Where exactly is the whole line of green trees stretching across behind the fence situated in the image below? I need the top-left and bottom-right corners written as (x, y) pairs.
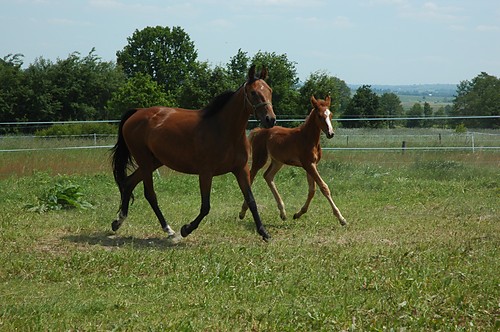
top-left (0, 26), bottom-right (500, 128)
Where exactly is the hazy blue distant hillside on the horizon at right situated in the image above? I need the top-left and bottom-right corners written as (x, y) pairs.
top-left (349, 84), bottom-right (457, 98)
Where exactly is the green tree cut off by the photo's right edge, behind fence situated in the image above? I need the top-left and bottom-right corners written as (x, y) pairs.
top-left (452, 72), bottom-right (500, 128)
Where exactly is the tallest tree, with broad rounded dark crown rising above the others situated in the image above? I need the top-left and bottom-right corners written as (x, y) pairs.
top-left (116, 26), bottom-right (198, 93)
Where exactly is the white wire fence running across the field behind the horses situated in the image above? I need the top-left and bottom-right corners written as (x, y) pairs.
top-left (0, 116), bottom-right (500, 153)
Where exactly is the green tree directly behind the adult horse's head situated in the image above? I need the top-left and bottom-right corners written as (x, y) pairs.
top-left (252, 51), bottom-right (298, 115)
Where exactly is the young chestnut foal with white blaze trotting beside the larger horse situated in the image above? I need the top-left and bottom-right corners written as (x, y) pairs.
top-left (240, 96), bottom-right (346, 225)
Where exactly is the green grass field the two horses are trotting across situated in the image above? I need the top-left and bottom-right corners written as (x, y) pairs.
top-left (0, 138), bottom-right (500, 331)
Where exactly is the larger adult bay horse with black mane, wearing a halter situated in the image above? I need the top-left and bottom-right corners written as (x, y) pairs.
top-left (111, 66), bottom-right (276, 240)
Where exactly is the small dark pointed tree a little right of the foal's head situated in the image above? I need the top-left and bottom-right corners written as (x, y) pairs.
top-left (341, 85), bottom-right (384, 128)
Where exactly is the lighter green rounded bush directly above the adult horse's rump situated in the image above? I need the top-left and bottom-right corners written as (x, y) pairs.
top-left (106, 73), bottom-right (176, 119)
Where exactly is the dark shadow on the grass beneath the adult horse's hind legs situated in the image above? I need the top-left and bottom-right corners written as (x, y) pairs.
top-left (62, 232), bottom-right (186, 249)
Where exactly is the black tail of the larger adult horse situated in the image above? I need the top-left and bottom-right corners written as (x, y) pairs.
top-left (111, 109), bottom-right (137, 188)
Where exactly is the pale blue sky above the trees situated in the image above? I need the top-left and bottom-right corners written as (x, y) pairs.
top-left (0, 0), bottom-right (500, 84)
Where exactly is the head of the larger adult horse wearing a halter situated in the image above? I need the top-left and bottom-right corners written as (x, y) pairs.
top-left (243, 65), bottom-right (276, 128)
